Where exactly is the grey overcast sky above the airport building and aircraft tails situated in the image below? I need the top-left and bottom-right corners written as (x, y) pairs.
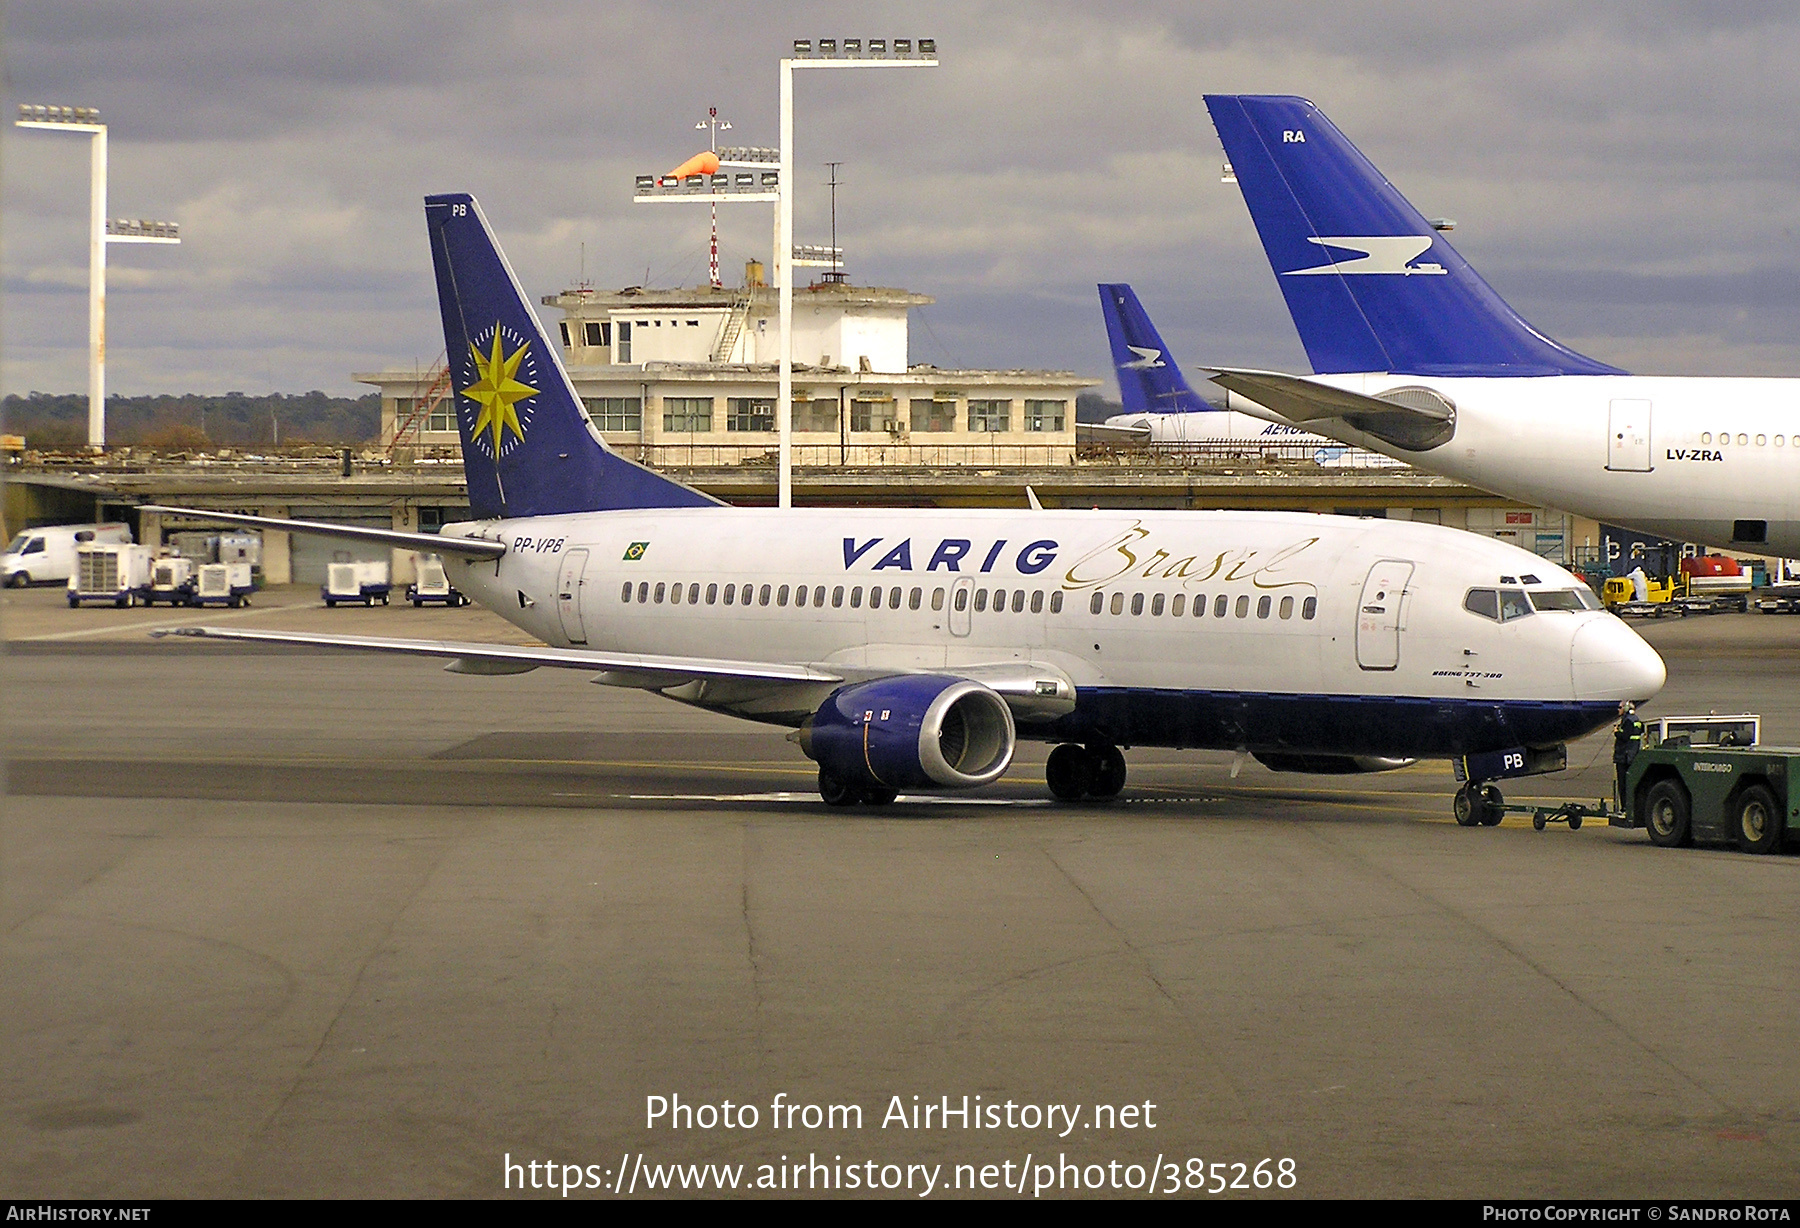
top-left (10, 0), bottom-right (1800, 394)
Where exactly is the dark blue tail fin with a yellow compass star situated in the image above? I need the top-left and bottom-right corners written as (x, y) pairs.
top-left (425, 193), bottom-right (718, 520)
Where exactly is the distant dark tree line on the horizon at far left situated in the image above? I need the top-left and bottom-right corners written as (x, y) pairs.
top-left (0, 391), bottom-right (382, 448)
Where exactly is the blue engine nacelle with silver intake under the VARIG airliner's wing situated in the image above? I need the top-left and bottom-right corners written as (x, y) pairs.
top-left (799, 673), bottom-right (1015, 789)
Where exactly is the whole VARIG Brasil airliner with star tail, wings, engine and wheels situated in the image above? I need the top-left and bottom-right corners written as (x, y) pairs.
top-left (151, 194), bottom-right (1663, 823)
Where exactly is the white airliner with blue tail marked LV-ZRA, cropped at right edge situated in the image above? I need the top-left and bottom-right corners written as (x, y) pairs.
top-left (1206, 94), bottom-right (1800, 556)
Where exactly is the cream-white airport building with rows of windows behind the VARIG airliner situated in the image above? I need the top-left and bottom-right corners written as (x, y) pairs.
top-left (356, 261), bottom-right (1098, 466)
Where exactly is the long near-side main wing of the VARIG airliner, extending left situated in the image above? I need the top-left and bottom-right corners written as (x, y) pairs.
top-left (151, 627), bottom-right (844, 690)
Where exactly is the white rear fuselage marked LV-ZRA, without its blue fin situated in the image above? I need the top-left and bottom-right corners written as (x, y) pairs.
top-left (1312, 375), bottom-right (1800, 556)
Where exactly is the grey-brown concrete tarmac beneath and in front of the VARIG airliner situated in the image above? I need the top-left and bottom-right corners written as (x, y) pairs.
top-left (0, 591), bottom-right (1800, 1197)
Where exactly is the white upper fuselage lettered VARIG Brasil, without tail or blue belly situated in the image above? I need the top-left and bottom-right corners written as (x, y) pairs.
top-left (445, 508), bottom-right (1663, 754)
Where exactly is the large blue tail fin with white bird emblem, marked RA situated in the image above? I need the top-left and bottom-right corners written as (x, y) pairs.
top-left (1206, 94), bottom-right (1622, 375)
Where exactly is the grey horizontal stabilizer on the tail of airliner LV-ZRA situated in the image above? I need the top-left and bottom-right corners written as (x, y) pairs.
top-left (1211, 367), bottom-right (1456, 452)
